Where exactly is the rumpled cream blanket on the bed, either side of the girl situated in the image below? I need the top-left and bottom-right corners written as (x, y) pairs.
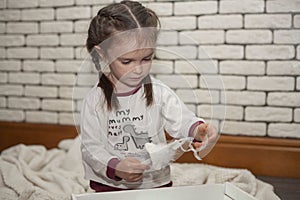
top-left (0, 138), bottom-right (279, 200)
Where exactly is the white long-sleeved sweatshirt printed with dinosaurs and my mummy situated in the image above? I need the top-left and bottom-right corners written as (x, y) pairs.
top-left (80, 78), bottom-right (203, 189)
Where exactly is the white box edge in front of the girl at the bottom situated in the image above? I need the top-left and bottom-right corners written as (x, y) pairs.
top-left (72, 183), bottom-right (256, 200)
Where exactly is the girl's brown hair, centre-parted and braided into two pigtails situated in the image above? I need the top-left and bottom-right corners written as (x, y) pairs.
top-left (86, 1), bottom-right (160, 110)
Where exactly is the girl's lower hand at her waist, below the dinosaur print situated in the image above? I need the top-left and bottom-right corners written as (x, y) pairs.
top-left (115, 158), bottom-right (149, 182)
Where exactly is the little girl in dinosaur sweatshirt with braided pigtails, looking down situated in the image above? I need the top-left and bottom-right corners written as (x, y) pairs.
top-left (80, 1), bottom-right (218, 192)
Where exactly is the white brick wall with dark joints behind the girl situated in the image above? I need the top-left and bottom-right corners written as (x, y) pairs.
top-left (0, 0), bottom-right (300, 139)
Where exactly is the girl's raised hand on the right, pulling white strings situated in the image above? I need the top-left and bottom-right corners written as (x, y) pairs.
top-left (194, 123), bottom-right (219, 157)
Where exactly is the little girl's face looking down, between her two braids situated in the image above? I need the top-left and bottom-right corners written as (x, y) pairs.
top-left (109, 48), bottom-right (154, 93)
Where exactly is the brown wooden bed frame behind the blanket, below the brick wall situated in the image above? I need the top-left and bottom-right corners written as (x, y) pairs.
top-left (0, 122), bottom-right (300, 178)
